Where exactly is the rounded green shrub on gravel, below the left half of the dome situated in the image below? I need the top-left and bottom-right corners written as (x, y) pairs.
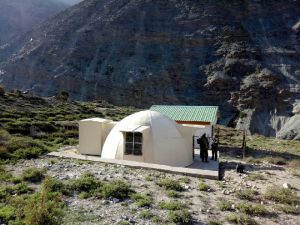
top-left (102, 180), bottom-right (133, 200)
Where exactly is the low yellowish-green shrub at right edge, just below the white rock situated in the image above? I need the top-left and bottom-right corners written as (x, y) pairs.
top-left (264, 185), bottom-right (299, 205)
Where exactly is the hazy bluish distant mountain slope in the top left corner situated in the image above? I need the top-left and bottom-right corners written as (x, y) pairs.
top-left (0, 0), bottom-right (78, 46)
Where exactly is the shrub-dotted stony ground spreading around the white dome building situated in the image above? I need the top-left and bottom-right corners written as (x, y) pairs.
top-left (0, 92), bottom-right (300, 225)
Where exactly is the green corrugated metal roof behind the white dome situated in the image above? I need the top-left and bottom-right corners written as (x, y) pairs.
top-left (150, 105), bottom-right (219, 123)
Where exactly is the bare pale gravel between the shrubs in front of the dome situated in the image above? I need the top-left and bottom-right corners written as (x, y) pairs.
top-left (7, 156), bottom-right (300, 225)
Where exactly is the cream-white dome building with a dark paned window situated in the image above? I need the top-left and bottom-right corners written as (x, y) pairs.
top-left (101, 110), bottom-right (193, 167)
